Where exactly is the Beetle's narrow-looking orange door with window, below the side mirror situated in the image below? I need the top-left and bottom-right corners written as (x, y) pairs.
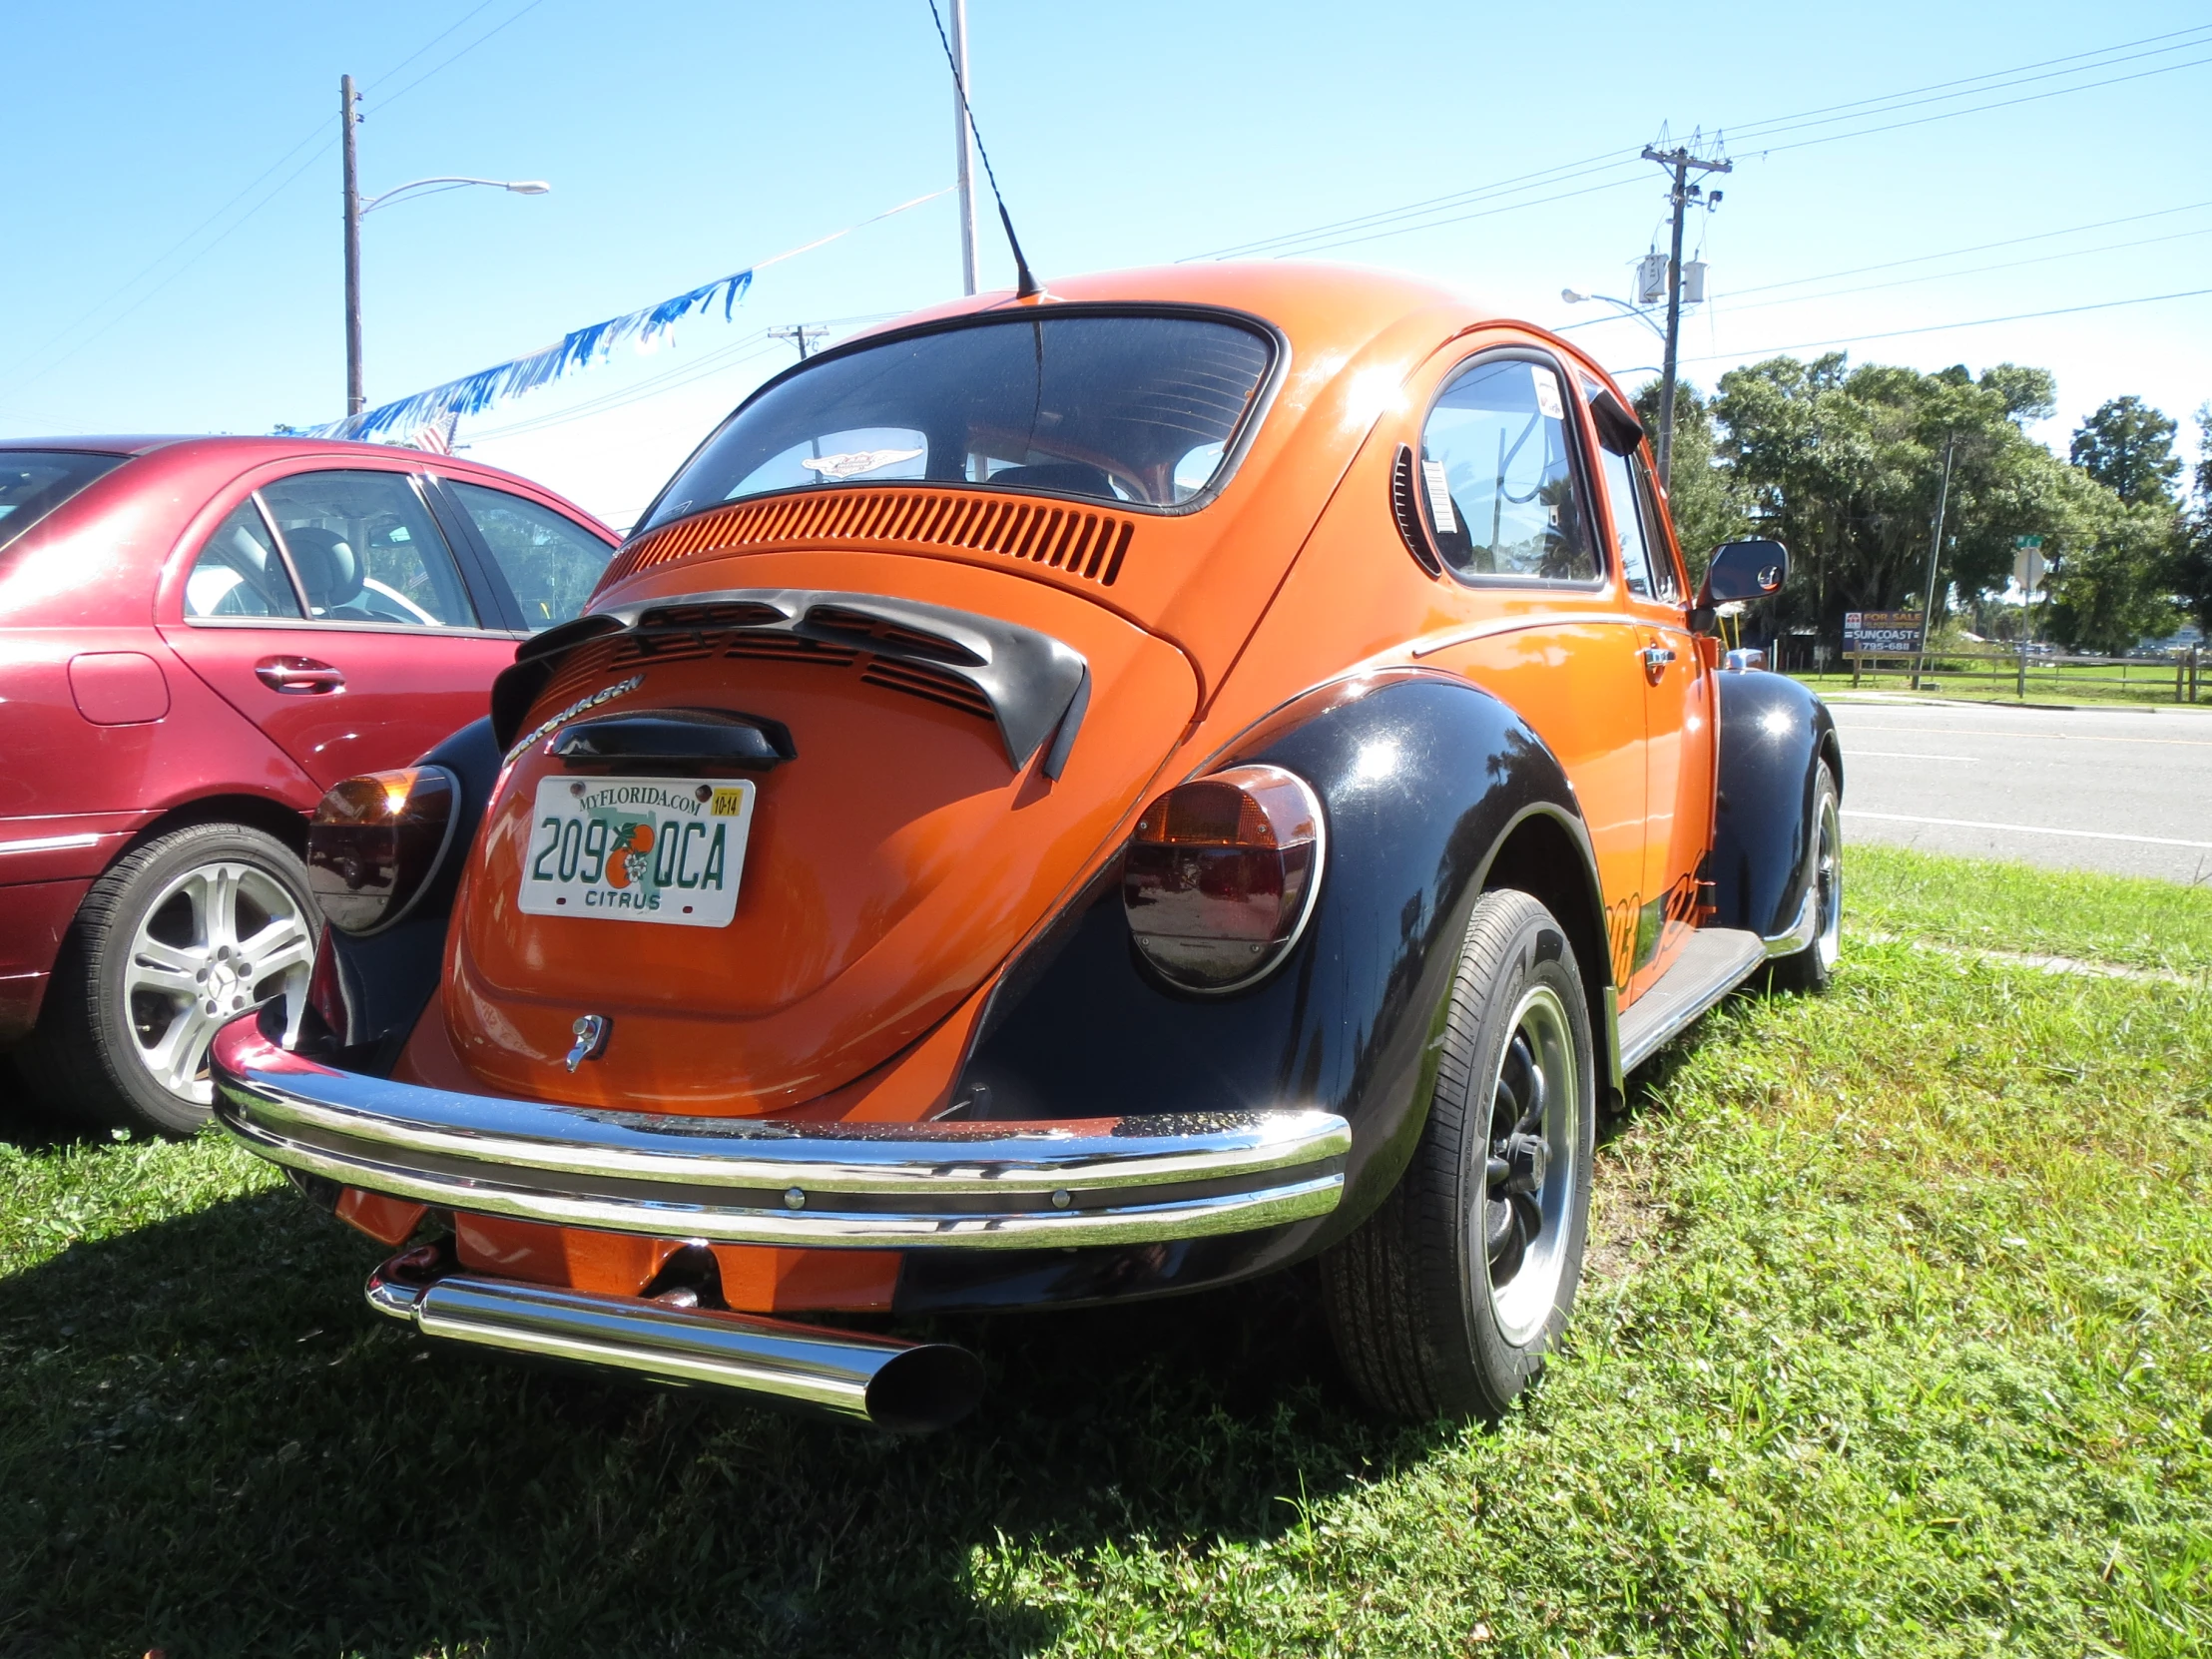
top-left (1599, 442), bottom-right (1712, 989)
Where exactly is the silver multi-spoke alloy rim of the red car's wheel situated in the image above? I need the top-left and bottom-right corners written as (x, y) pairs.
top-left (124, 858), bottom-right (314, 1106)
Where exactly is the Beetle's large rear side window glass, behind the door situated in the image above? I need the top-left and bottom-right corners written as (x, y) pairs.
top-left (1420, 356), bottom-right (1601, 582)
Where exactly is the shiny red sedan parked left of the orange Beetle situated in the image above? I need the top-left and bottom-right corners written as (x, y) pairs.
top-left (0, 438), bottom-right (615, 1133)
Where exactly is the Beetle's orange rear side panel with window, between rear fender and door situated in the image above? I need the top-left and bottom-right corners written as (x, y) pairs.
top-left (1415, 347), bottom-right (1648, 984)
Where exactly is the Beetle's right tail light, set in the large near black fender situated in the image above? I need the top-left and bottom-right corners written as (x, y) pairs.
top-left (1122, 766), bottom-right (1325, 991)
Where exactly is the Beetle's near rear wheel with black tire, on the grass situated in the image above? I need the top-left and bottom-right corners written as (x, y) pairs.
top-left (1321, 889), bottom-right (1597, 1420)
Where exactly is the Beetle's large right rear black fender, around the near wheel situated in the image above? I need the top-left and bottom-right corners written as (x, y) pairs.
top-left (898, 670), bottom-right (1610, 1312)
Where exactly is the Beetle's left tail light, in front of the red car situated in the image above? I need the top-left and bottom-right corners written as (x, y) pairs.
top-left (307, 766), bottom-right (460, 933)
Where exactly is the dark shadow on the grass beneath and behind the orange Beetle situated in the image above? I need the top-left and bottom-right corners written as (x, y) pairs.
top-left (0, 1190), bottom-right (1446, 1659)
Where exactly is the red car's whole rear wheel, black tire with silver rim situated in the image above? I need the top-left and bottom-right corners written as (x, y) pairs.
top-left (22, 823), bottom-right (323, 1135)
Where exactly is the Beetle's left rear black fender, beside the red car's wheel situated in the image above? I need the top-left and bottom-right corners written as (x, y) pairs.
top-left (296, 719), bottom-right (504, 1077)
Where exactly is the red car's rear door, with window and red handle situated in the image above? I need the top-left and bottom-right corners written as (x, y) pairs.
top-left (162, 467), bottom-right (515, 788)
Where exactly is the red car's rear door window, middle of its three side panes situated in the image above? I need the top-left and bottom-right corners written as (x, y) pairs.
top-left (261, 471), bottom-right (475, 628)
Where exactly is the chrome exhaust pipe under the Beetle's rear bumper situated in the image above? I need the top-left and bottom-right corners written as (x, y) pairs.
top-left (367, 1250), bottom-right (982, 1433)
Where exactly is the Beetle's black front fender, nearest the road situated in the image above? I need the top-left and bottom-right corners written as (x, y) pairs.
top-left (1708, 670), bottom-right (1843, 938)
